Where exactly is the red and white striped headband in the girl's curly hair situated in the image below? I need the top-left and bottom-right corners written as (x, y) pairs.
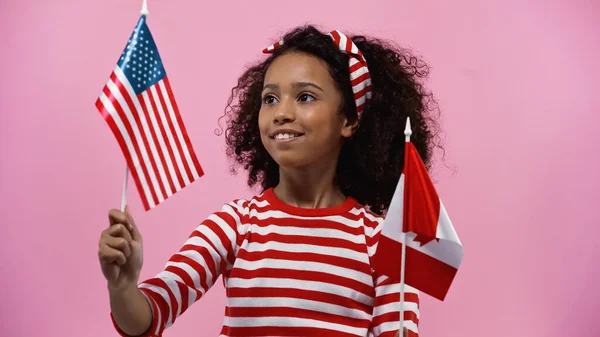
top-left (263, 30), bottom-right (373, 119)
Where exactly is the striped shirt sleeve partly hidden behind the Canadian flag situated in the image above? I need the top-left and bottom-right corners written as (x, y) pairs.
top-left (366, 213), bottom-right (419, 337)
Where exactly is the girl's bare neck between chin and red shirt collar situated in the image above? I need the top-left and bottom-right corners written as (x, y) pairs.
top-left (274, 157), bottom-right (346, 208)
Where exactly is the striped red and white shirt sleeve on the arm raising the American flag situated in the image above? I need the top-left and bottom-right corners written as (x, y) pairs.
top-left (111, 201), bottom-right (245, 337)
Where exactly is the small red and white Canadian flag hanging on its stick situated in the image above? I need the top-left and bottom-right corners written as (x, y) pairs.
top-left (373, 127), bottom-right (463, 301)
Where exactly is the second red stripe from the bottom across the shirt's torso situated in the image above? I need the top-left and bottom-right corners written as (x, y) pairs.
top-left (225, 307), bottom-right (371, 329)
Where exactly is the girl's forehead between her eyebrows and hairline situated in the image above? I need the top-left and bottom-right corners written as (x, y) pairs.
top-left (265, 53), bottom-right (334, 85)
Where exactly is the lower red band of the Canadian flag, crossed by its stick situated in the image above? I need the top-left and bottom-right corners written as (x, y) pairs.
top-left (372, 235), bottom-right (457, 301)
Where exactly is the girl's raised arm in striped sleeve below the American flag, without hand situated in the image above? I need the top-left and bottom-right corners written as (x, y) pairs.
top-left (111, 204), bottom-right (241, 336)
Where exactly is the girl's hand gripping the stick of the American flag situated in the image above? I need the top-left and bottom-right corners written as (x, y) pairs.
top-left (98, 207), bottom-right (143, 290)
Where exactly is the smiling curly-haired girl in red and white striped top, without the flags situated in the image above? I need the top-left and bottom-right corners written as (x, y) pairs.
top-left (99, 26), bottom-right (437, 337)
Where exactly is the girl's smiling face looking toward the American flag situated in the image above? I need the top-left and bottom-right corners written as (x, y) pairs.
top-left (258, 52), bottom-right (354, 168)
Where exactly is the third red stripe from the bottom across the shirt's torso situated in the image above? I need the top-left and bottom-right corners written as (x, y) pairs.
top-left (226, 287), bottom-right (372, 313)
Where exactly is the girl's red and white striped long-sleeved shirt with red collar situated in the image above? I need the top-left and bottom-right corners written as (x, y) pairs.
top-left (113, 189), bottom-right (419, 337)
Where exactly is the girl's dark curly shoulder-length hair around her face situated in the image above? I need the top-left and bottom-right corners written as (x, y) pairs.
top-left (223, 25), bottom-right (439, 214)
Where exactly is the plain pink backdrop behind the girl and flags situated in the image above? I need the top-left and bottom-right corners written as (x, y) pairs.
top-left (0, 0), bottom-right (600, 337)
